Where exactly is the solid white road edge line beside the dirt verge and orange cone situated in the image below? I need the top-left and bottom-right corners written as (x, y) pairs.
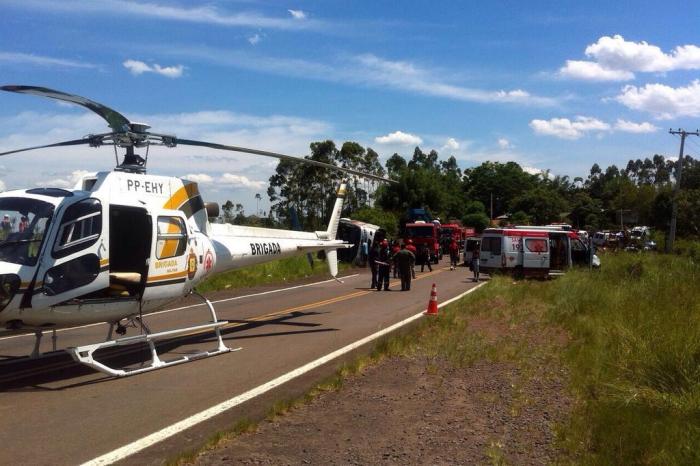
top-left (81, 282), bottom-right (486, 466)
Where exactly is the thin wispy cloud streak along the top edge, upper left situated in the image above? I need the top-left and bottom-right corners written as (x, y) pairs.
top-left (16, 0), bottom-right (323, 30)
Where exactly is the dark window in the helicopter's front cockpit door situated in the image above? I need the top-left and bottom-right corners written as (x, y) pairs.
top-left (53, 198), bottom-right (102, 258)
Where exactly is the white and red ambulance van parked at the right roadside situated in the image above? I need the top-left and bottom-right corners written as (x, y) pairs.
top-left (479, 227), bottom-right (600, 277)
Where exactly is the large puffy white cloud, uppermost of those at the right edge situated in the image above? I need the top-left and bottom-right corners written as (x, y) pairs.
top-left (559, 34), bottom-right (700, 81)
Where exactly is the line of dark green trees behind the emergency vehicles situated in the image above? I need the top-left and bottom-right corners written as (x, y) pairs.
top-left (224, 140), bottom-right (700, 236)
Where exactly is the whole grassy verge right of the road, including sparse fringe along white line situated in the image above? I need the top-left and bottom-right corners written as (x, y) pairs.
top-left (179, 249), bottom-right (700, 465)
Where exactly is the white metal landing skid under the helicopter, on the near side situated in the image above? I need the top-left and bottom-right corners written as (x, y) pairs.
top-left (66, 298), bottom-right (241, 377)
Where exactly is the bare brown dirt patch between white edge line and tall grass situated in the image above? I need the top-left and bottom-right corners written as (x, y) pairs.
top-left (197, 318), bottom-right (571, 465)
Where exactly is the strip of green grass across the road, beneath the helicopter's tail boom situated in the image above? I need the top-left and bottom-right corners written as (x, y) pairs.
top-left (197, 255), bottom-right (351, 293)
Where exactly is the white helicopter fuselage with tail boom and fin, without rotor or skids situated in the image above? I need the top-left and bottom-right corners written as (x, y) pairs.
top-left (0, 171), bottom-right (347, 329)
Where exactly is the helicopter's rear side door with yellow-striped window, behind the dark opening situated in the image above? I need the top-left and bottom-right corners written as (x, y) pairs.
top-left (143, 210), bottom-right (188, 301)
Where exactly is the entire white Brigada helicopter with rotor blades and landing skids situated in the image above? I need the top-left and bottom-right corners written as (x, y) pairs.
top-left (0, 85), bottom-right (390, 377)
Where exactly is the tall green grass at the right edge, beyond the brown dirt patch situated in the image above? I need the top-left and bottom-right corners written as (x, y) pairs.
top-left (542, 253), bottom-right (700, 464)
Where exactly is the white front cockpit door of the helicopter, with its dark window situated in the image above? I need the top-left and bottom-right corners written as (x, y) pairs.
top-left (32, 198), bottom-right (109, 307)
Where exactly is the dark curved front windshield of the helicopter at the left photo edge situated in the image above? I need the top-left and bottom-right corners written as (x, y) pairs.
top-left (0, 197), bottom-right (53, 265)
